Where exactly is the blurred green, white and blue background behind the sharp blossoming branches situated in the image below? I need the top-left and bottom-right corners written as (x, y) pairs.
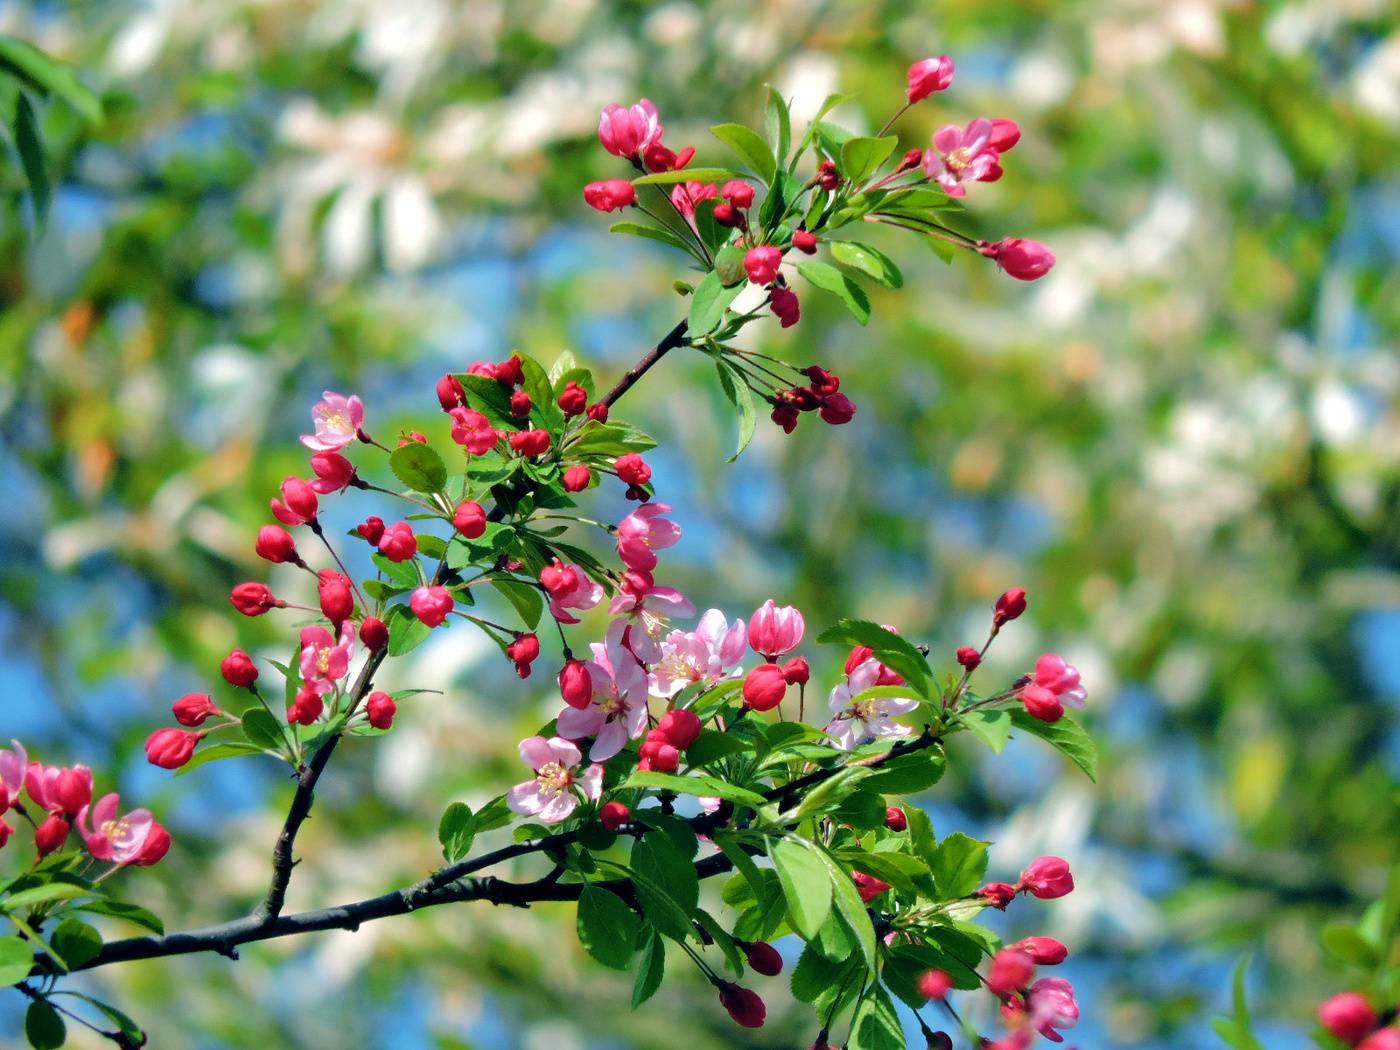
top-left (0, 0), bottom-right (1400, 1050)
